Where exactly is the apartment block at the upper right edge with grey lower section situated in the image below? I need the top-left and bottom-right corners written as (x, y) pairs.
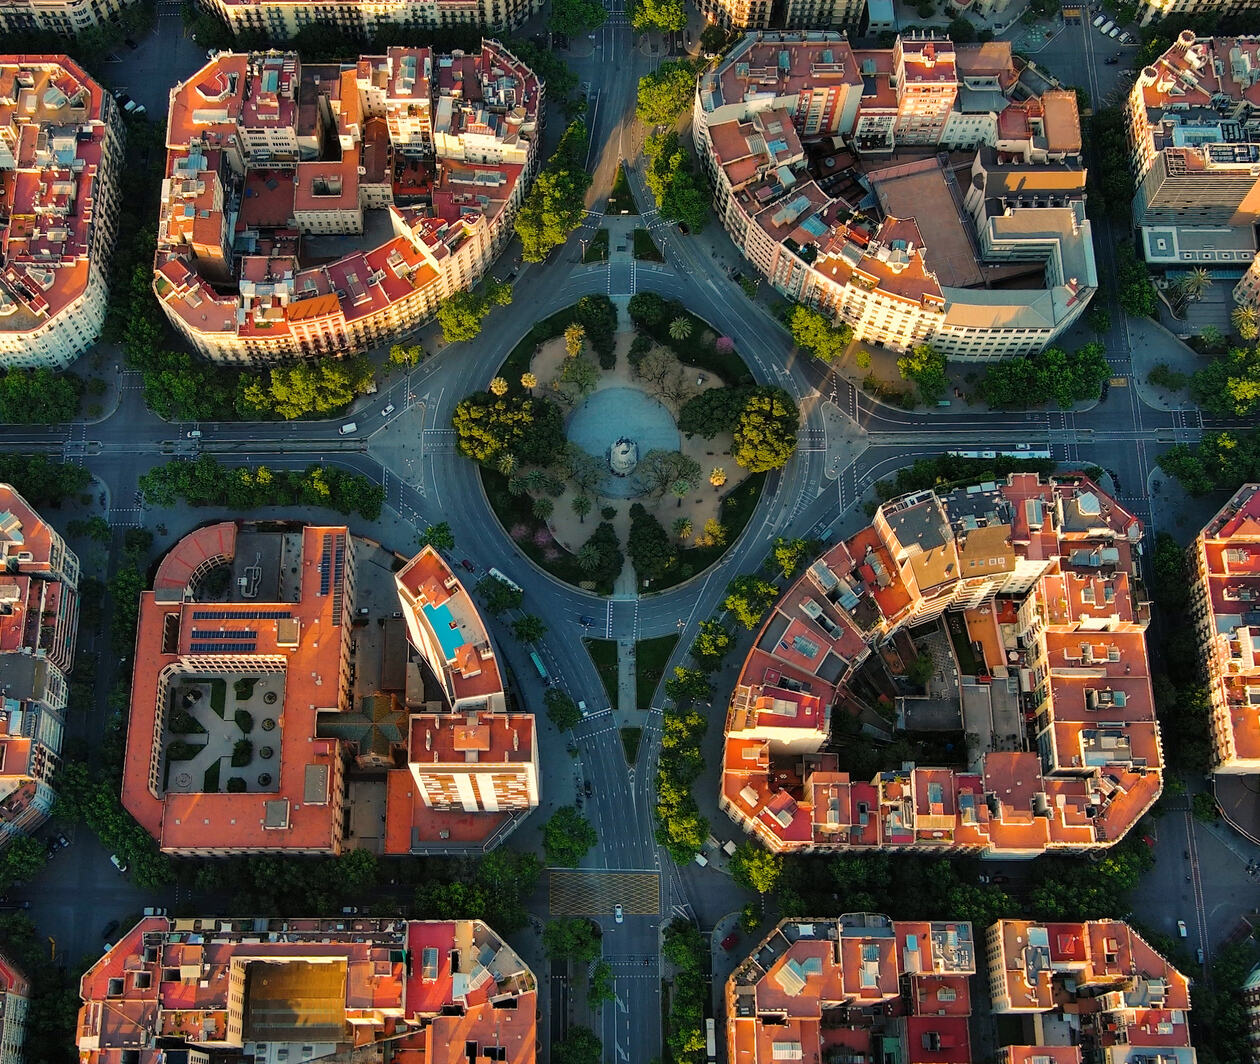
top-left (1125, 30), bottom-right (1260, 268)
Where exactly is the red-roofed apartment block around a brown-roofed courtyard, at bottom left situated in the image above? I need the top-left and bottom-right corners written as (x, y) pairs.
top-left (76, 917), bottom-right (538, 1064)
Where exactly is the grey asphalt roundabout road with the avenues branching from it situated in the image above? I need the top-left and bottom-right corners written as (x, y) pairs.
top-left (4, 10), bottom-right (1255, 1064)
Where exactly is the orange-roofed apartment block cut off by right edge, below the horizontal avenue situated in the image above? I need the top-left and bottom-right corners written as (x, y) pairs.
top-left (1189, 484), bottom-right (1260, 775)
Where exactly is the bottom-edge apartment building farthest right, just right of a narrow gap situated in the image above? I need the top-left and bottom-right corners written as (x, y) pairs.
top-left (985, 920), bottom-right (1196, 1064)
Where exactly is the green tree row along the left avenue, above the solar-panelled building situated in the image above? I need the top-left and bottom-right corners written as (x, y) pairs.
top-left (140, 454), bottom-right (384, 521)
